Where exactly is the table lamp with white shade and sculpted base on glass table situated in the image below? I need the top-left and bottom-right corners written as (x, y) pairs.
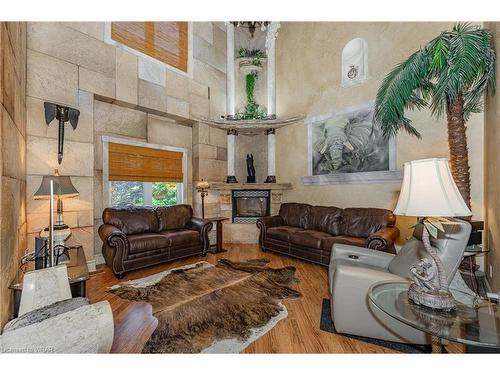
top-left (394, 158), bottom-right (471, 311)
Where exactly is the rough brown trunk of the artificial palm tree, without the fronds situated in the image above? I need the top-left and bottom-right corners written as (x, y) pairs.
top-left (446, 95), bottom-right (471, 209)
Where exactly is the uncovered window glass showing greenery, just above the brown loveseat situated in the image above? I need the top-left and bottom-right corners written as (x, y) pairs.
top-left (109, 181), bottom-right (182, 207)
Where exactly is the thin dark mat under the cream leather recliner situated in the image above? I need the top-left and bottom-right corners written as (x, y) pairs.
top-left (319, 298), bottom-right (432, 354)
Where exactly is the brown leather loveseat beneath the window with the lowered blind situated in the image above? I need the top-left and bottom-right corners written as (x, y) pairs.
top-left (99, 204), bottom-right (212, 278)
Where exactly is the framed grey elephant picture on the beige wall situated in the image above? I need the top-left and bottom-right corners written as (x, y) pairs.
top-left (303, 101), bottom-right (401, 184)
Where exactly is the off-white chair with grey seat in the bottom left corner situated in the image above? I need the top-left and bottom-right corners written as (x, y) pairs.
top-left (0, 265), bottom-right (114, 353)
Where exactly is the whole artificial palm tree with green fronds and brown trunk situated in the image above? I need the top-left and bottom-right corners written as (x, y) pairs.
top-left (374, 24), bottom-right (495, 208)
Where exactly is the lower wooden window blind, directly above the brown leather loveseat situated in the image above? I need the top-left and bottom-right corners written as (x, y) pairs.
top-left (108, 143), bottom-right (183, 182)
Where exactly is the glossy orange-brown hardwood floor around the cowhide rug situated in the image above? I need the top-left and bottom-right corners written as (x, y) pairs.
top-left (87, 244), bottom-right (396, 353)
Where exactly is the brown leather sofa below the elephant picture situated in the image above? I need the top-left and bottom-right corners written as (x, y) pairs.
top-left (257, 203), bottom-right (399, 266)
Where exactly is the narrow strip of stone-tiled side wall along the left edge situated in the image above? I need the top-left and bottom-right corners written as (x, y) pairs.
top-left (0, 22), bottom-right (27, 329)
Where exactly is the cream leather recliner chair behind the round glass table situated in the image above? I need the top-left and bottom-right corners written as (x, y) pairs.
top-left (329, 219), bottom-right (471, 345)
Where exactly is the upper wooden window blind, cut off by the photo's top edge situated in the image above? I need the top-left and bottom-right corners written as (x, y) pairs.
top-left (111, 22), bottom-right (188, 72)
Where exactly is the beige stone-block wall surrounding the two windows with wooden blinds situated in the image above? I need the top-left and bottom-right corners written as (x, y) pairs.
top-left (26, 22), bottom-right (226, 266)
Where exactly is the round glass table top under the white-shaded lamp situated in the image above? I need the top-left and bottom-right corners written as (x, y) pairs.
top-left (368, 281), bottom-right (500, 348)
